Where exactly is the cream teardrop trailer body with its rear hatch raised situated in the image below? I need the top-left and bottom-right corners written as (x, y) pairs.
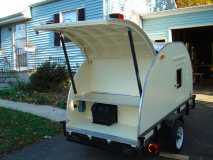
top-left (35, 20), bottom-right (193, 146)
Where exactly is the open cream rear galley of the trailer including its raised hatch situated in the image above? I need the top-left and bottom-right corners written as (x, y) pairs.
top-left (35, 20), bottom-right (155, 145)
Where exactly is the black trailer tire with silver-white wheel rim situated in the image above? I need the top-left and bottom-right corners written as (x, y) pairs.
top-left (168, 120), bottom-right (184, 153)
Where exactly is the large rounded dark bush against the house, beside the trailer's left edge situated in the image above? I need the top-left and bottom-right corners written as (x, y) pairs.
top-left (30, 62), bottom-right (69, 92)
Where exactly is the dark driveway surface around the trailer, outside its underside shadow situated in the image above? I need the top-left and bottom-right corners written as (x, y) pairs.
top-left (3, 103), bottom-right (213, 160)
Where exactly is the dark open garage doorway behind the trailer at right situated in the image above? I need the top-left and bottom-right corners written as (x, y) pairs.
top-left (172, 26), bottom-right (213, 85)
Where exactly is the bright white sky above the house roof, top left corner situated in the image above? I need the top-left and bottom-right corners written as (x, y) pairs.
top-left (0, 0), bottom-right (42, 17)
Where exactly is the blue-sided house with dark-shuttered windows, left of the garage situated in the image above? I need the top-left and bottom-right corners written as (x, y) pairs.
top-left (0, 0), bottom-right (145, 71)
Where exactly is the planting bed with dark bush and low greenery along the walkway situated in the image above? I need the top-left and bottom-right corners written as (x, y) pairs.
top-left (0, 65), bottom-right (69, 108)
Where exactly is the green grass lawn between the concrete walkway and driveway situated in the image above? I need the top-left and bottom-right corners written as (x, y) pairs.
top-left (0, 108), bottom-right (62, 154)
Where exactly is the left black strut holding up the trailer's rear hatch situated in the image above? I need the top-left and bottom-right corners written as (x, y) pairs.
top-left (59, 33), bottom-right (77, 94)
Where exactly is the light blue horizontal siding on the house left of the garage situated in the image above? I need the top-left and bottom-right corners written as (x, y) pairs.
top-left (0, 0), bottom-right (103, 70)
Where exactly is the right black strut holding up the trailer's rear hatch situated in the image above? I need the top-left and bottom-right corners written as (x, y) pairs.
top-left (128, 28), bottom-right (142, 97)
